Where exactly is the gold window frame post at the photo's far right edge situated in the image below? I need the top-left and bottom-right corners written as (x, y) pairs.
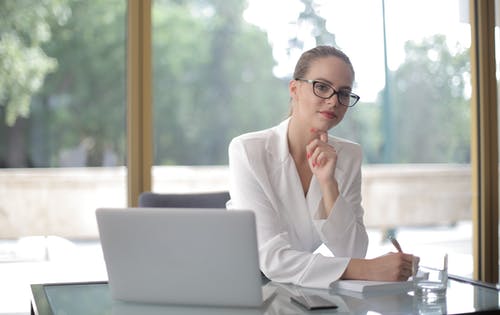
top-left (469, 0), bottom-right (499, 283)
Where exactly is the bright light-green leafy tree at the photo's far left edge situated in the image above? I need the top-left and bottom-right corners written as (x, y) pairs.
top-left (0, 0), bottom-right (71, 167)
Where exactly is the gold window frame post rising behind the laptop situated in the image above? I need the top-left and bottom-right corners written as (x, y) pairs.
top-left (127, 0), bottom-right (153, 206)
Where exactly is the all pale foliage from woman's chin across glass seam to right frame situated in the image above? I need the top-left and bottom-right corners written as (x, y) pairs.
top-left (333, 34), bottom-right (470, 163)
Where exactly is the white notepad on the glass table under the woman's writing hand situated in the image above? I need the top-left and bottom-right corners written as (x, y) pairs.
top-left (331, 280), bottom-right (413, 293)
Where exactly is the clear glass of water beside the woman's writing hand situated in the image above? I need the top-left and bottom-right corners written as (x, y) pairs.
top-left (413, 254), bottom-right (448, 301)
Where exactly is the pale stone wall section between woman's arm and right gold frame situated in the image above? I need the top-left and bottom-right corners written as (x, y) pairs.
top-left (362, 164), bottom-right (472, 228)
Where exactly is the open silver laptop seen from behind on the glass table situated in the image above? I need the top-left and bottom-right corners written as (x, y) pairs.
top-left (96, 208), bottom-right (263, 307)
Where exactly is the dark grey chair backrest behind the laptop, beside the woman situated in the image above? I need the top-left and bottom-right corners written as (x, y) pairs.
top-left (139, 191), bottom-right (230, 208)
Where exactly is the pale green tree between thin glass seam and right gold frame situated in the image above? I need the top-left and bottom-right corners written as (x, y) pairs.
top-left (391, 35), bottom-right (470, 163)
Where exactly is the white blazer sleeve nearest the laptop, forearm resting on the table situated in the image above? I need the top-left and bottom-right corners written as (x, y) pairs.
top-left (228, 138), bottom-right (350, 288)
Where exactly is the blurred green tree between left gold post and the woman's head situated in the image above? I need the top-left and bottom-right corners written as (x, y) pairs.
top-left (153, 0), bottom-right (288, 165)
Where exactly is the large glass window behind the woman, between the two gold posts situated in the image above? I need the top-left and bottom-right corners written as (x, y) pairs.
top-left (153, 0), bottom-right (472, 276)
